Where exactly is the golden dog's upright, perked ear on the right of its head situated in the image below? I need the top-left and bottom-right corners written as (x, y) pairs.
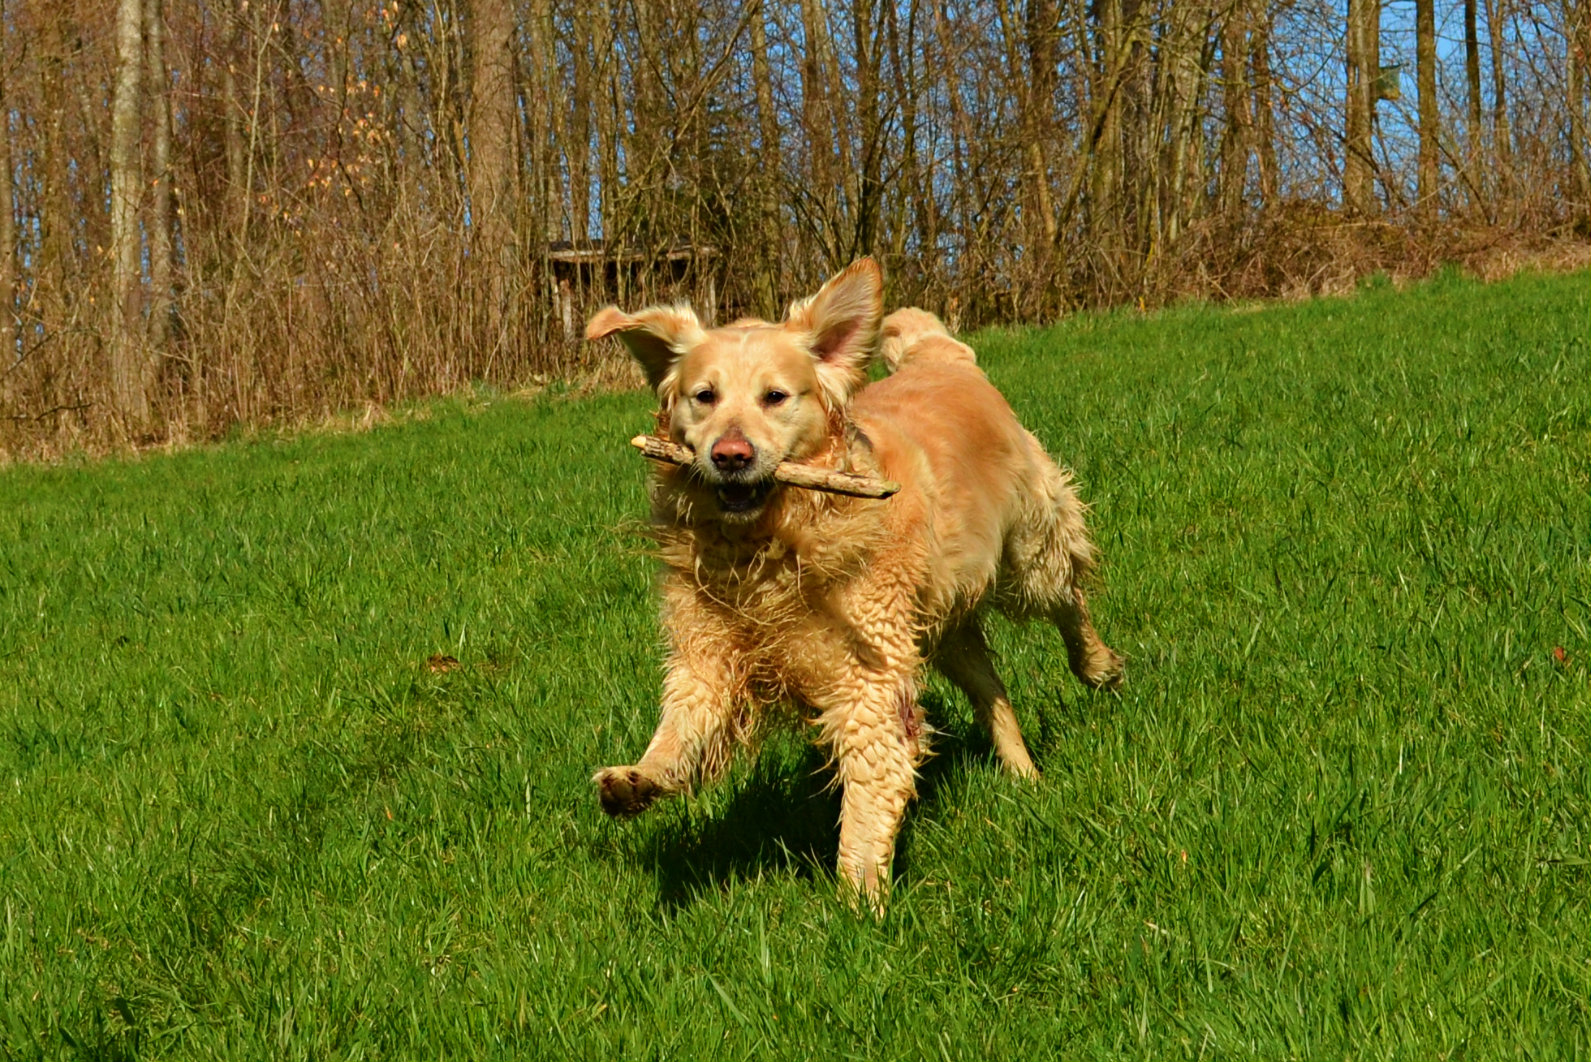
top-left (784, 258), bottom-right (885, 405)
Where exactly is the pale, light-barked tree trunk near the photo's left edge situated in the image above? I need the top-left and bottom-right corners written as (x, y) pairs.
top-left (110, 0), bottom-right (150, 434)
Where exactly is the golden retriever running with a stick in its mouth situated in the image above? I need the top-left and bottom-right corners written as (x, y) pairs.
top-left (585, 258), bottom-right (1123, 908)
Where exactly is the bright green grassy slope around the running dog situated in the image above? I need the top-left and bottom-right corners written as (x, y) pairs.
top-left (0, 273), bottom-right (1591, 1059)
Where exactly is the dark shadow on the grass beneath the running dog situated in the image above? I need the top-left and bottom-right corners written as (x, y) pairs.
top-left (633, 695), bottom-right (1043, 911)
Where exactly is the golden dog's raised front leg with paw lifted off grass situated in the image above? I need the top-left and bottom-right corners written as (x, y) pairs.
top-left (592, 655), bottom-right (746, 817)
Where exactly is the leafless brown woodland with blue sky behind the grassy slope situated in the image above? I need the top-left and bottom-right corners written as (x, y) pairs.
top-left (0, 0), bottom-right (1591, 458)
